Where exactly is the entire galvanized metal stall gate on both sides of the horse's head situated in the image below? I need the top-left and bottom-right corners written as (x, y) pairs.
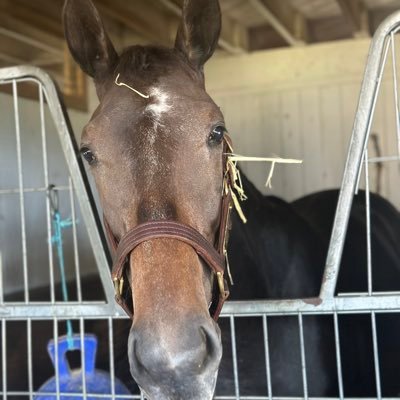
top-left (0, 8), bottom-right (400, 400)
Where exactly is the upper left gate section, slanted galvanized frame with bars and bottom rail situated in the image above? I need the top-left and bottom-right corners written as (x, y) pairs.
top-left (0, 66), bottom-right (123, 319)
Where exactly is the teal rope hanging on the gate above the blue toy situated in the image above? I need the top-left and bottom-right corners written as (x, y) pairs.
top-left (51, 210), bottom-right (74, 350)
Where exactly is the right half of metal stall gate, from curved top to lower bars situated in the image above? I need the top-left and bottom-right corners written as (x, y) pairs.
top-left (219, 8), bottom-right (400, 399)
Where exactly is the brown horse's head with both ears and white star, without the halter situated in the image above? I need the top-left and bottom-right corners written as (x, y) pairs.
top-left (63, 0), bottom-right (225, 400)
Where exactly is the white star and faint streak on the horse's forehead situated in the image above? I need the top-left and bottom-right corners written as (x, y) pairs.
top-left (145, 87), bottom-right (172, 175)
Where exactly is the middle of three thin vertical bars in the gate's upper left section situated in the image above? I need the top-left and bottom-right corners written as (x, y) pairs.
top-left (38, 84), bottom-right (56, 304)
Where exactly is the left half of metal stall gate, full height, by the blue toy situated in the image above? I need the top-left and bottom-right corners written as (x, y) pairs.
top-left (0, 67), bottom-right (142, 399)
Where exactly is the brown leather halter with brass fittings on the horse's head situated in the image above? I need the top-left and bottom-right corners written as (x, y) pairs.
top-left (104, 135), bottom-right (232, 320)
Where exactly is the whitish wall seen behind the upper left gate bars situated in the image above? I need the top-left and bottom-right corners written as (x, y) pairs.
top-left (0, 90), bottom-right (96, 294)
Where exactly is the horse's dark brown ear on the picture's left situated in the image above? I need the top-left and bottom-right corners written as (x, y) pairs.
top-left (63, 0), bottom-right (118, 80)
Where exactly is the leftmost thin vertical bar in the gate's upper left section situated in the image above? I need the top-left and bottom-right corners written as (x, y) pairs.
top-left (12, 79), bottom-right (29, 303)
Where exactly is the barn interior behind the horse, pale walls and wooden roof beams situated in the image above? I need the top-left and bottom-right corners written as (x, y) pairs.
top-left (0, 0), bottom-right (400, 396)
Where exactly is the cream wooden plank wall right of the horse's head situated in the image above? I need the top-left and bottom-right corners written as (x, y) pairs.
top-left (206, 39), bottom-right (400, 208)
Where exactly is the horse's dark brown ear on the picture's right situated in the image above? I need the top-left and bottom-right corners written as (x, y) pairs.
top-left (175, 0), bottom-right (221, 70)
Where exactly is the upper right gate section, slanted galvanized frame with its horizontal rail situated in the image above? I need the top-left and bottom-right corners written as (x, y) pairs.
top-left (223, 12), bottom-right (400, 315)
